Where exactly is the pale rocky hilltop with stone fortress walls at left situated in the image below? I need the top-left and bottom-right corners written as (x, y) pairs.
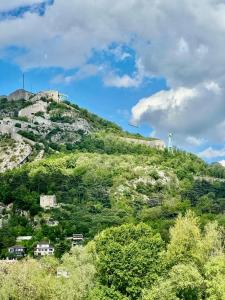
top-left (0, 90), bottom-right (92, 172)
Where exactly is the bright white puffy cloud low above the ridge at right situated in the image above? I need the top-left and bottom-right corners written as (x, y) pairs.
top-left (132, 82), bottom-right (225, 146)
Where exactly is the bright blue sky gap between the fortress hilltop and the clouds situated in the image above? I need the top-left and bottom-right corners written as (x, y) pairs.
top-left (0, 53), bottom-right (166, 136)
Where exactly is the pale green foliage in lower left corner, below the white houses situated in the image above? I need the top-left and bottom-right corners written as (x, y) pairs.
top-left (0, 247), bottom-right (95, 300)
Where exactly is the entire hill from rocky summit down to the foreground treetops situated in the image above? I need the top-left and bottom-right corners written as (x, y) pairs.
top-left (0, 91), bottom-right (225, 257)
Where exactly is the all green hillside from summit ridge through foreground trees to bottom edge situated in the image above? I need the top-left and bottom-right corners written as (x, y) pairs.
top-left (0, 94), bottom-right (225, 300)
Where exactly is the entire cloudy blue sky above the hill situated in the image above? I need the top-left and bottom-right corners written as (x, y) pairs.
top-left (0, 0), bottom-right (225, 161)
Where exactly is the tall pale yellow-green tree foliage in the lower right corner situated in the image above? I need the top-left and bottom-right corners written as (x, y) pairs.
top-left (144, 211), bottom-right (225, 300)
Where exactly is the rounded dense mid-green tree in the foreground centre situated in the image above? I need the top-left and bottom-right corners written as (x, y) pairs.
top-left (94, 224), bottom-right (164, 299)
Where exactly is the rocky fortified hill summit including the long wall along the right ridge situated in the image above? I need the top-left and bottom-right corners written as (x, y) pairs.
top-left (0, 89), bottom-right (165, 172)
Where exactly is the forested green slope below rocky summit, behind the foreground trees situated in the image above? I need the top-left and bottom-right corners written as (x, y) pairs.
top-left (0, 131), bottom-right (225, 257)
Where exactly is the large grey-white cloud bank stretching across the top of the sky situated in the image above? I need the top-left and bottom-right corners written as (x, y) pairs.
top-left (0, 0), bottom-right (225, 83)
